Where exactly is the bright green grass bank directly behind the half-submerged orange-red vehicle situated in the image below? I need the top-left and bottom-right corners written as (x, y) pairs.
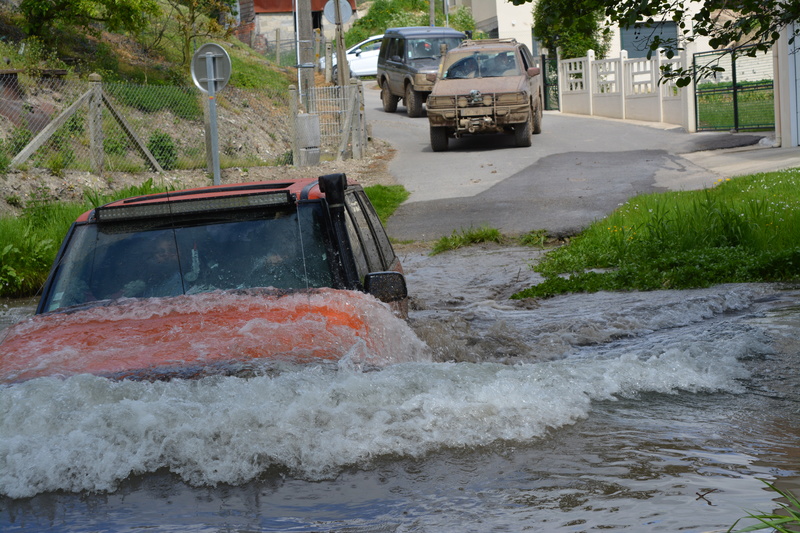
top-left (0, 181), bottom-right (408, 298)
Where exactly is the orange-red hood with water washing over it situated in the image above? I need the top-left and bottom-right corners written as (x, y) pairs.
top-left (0, 289), bottom-right (419, 383)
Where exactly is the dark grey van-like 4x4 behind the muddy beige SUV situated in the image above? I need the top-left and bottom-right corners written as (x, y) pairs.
top-left (378, 26), bottom-right (466, 117)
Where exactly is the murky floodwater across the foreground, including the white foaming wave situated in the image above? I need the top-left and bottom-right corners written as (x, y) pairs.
top-left (0, 247), bottom-right (800, 532)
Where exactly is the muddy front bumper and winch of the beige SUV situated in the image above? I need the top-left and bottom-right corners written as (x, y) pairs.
top-left (427, 90), bottom-right (530, 136)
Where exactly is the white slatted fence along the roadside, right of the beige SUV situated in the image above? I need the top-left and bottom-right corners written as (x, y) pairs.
top-left (558, 50), bottom-right (695, 131)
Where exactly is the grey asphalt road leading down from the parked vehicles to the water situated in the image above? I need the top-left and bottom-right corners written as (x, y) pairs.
top-left (364, 82), bottom-right (772, 240)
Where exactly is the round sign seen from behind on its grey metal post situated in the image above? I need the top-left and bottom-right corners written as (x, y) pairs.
top-left (191, 43), bottom-right (231, 185)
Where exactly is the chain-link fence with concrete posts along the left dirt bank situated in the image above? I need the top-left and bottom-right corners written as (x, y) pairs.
top-left (0, 71), bottom-right (366, 172)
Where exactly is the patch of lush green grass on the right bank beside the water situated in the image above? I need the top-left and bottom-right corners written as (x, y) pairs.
top-left (514, 169), bottom-right (800, 298)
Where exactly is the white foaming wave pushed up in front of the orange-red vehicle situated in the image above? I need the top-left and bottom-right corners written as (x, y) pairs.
top-left (0, 343), bottom-right (748, 498)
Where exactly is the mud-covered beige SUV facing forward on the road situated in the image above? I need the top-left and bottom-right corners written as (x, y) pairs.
top-left (426, 39), bottom-right (544, 152)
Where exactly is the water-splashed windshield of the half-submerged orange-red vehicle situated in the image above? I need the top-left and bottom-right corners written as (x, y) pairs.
top-left (42, 203), bottom-right (333, 311)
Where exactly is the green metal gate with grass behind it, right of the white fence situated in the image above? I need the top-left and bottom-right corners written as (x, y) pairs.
top-left (693, 48), bottom-right (775, 131)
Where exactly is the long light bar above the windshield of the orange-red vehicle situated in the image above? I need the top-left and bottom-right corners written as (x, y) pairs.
top-left (95, 191), bottom-right (293, 222)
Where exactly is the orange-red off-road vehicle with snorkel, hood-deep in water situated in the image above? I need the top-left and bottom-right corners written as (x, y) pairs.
top-left (0, 174), bottom-right (407, 382)
